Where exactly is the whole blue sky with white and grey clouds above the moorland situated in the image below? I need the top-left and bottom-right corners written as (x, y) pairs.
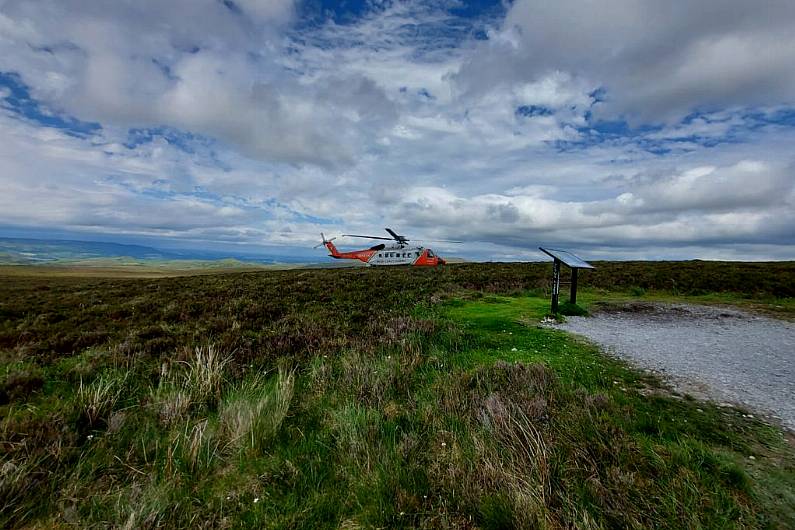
top-left (0, 0), bottom-right (795, 260)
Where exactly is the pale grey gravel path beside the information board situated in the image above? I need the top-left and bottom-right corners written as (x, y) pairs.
top-left (556, 303), bottom-right (795, 430)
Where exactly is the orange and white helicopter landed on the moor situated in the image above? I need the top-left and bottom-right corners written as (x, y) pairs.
top-left (315, 228), bottom-right (461, 267)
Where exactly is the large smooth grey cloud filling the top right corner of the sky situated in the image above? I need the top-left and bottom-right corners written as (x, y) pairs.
top-left (457, 0), bottom-right (795, 121)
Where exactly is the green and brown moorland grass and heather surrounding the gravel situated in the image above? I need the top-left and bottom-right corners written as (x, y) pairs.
top-left (0, 262), bottom-right (795, 528)
